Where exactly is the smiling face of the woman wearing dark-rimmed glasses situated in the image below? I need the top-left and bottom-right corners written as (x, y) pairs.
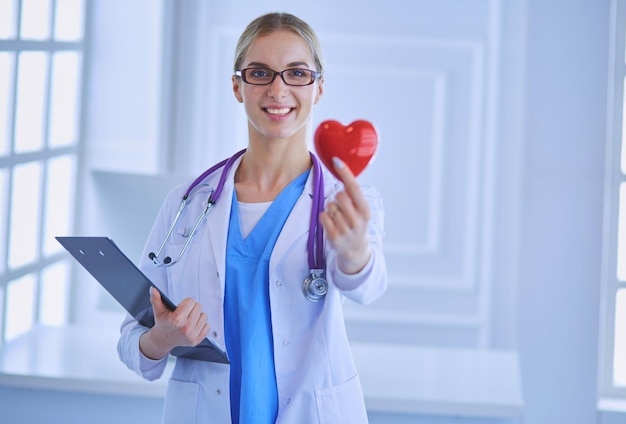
top-left (233, 30), bottom-right (322, 140)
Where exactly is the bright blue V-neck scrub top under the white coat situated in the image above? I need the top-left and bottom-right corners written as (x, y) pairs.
top-left (224, 171), bottom-right (310, 424)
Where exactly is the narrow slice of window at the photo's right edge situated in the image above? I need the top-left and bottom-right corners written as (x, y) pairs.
top-left (600, 0), bottom-right (626, 406)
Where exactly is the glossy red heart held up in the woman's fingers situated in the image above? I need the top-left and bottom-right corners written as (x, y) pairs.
top-left (314, 120), bottom-right (378, 178)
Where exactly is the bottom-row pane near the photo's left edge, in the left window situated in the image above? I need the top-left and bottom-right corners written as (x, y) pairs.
top-left (4, 274), bottom-right (35, 341)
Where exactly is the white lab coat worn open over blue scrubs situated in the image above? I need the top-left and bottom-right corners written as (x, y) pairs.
top-left (118, 154), bottom-right (387, 424)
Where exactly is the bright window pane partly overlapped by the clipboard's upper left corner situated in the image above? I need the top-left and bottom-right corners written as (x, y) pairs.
top-left (43, 155), bottom-right (76, 255)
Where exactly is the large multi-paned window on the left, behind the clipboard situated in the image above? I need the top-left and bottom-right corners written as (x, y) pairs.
top-left (0, 0), bottom-right (84, 345)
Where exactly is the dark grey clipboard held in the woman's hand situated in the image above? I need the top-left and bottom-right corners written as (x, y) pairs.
top-left (55, 236), bottom-right (229, 364)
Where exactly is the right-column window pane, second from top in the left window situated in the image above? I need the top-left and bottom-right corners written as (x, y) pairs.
top-left (49, 52), bottom-right (80, 147)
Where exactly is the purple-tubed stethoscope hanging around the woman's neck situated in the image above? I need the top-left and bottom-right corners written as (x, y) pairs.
top-left (148, 149), bottom-right (328, 302)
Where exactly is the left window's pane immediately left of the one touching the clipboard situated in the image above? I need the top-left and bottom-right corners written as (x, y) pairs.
top-left (9, 162), bottom-right (42, 268)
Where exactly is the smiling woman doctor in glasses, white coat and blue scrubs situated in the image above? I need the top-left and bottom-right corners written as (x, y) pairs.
top-left (118, 13), bottom-right (387, 424)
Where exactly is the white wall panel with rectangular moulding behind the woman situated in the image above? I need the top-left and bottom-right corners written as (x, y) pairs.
top-left (188, 1), bottom-right (510, 346)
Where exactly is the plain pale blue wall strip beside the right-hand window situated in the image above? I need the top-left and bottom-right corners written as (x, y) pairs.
top-left (518, 0), bottom-right (608, 424)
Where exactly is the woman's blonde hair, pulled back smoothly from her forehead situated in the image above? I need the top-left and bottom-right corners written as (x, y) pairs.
top-left (234, 13), bottom-right (324, 73)
